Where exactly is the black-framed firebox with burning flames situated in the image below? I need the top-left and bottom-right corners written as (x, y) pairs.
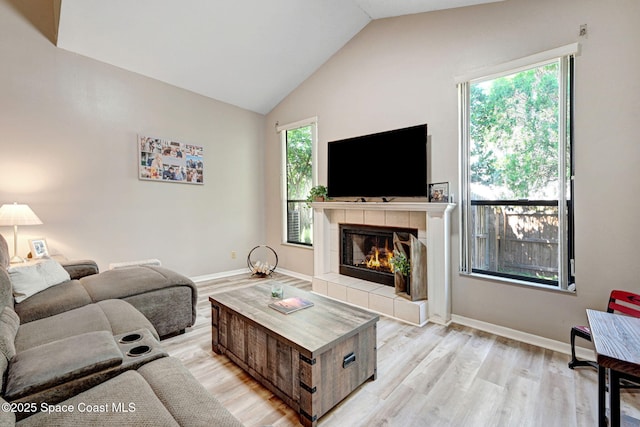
top-left (339, 224), bottom-right (418, 286)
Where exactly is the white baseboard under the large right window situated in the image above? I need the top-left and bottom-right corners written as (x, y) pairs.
top-left (451, 314), bottom-right (595, 360)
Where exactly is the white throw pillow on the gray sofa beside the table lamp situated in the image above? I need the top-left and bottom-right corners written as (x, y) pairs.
top-left (7, 259), bottom-right (71, 303)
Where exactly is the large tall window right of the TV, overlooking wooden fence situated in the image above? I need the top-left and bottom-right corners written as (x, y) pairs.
top-left (459, 46), bottom-right (574, 289)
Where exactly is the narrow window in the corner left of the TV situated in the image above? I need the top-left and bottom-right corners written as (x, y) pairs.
top-left (278, 119), bottom-right (316, 246)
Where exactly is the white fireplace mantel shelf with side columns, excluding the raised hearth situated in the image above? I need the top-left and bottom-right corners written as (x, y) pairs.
top-left (312, 202), bottom-right (456, 325)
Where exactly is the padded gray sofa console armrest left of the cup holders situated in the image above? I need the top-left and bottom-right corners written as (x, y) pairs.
top-left (5, 331), bottom-right (122, 400)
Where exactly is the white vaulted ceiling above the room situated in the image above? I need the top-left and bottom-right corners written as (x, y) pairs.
top-left (57, 0), bottom-right (502, 114)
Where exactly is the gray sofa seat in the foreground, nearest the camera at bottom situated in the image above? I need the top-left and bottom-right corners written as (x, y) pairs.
top-left (9, 357), bottom-right (242, 427)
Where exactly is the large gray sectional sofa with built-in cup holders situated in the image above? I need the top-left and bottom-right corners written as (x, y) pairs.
top-left (0, 236), bottom-right (242, 426)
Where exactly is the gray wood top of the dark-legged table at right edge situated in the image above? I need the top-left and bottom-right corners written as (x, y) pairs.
top-left (587, 309), bottom-right (640, 376)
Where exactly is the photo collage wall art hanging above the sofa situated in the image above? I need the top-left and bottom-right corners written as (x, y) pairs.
top-left (138, 135), bottom-right (204, 185)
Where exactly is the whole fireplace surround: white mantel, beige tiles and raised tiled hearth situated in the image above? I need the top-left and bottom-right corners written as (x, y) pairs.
top-left (313, 202), bottom-right (455, 325)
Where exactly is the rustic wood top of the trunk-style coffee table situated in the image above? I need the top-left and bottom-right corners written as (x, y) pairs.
top-left (209, 282), bottom-right (380, 355)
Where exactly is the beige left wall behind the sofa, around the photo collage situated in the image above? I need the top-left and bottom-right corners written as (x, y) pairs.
top-left (0, 0), bottom-right (265, 276)
